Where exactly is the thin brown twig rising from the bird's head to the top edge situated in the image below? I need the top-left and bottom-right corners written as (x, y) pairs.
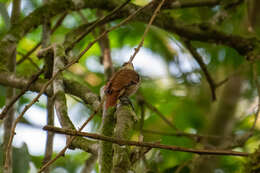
top-left (128, 0), bottom-right (165, 62)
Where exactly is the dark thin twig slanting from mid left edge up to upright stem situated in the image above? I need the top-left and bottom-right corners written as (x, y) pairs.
top-left (0, 69), bottom-right (43, 119)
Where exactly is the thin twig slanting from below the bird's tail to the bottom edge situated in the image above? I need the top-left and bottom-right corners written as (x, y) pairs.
top-left (38, 110), bottom-right (99, 173)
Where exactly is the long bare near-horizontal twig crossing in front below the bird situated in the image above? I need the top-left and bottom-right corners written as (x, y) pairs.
top-left (43, 126), bottom-right (249, 157)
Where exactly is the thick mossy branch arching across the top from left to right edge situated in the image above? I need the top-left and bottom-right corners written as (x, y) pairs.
top-left (0, 0), bottom-right (260, 69)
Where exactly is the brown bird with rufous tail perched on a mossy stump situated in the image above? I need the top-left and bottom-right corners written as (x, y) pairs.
top-left (104, 62), bottom-right (140, 109)
